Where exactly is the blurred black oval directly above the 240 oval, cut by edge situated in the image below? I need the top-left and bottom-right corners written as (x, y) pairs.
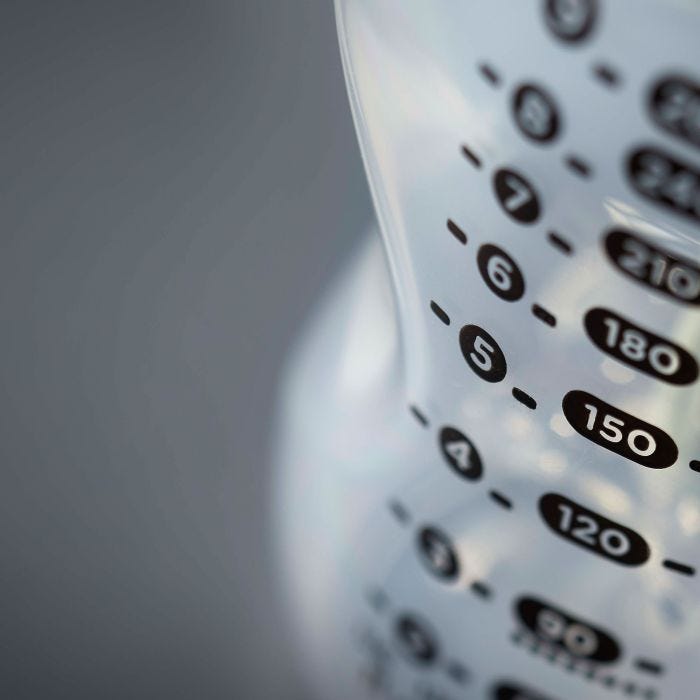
top-left (649, 75), bottom-right (700, 146)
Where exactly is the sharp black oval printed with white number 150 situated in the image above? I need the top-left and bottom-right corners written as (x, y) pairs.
top-left (562, 390), bottom-right (678, 469)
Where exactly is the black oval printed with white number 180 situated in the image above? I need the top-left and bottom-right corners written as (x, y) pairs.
top-left (583, 308), bottom-right (698, 384)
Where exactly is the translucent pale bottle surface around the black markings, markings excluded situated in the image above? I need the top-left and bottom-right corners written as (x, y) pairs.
top-left (275, 0), bottom-right (700, 700)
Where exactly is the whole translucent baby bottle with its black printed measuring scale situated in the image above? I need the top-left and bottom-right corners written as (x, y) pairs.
top-left (274, 0), bottom-right (700, 700)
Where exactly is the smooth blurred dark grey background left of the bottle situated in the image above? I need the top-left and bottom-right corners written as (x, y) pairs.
top-left (0, 0), bottom-right (371, 700)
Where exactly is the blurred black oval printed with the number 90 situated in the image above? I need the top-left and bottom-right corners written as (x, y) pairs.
top-left (515, 597), bottom-right (622, 664)
